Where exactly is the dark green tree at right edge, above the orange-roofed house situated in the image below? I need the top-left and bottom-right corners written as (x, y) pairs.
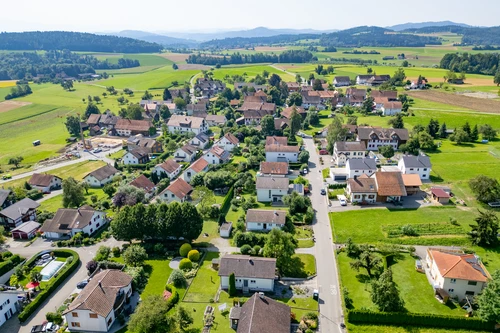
top-left (469, 210), bottom-right (499, 247)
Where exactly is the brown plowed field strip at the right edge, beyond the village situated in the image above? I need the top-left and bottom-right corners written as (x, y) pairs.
top-left (407, 90), bottom-right (500, 114)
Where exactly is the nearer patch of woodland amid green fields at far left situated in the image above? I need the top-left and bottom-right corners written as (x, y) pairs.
top-left (0, 50), bottom-right (140, 80)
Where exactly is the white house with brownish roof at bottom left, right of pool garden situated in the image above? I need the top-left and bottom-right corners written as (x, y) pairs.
top-left (63, 269), bottom-right (132, 332)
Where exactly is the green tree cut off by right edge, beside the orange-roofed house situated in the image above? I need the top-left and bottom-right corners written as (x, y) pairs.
top-left (476, 270), bottom-right (500, 323)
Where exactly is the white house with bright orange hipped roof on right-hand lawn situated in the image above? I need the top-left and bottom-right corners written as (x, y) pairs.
top-left (426, 248), bottom-right (491, 301)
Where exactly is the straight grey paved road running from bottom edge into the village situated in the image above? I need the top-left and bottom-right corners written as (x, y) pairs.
top-left (304, 138), bottom-right (343, 333)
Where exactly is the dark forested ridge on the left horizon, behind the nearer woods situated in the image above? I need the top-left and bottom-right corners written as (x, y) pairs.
top-left (0, 31), bottom-right (162, 53)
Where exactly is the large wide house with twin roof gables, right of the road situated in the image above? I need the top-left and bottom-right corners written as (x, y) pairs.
top-left (357, 126), bottom-right (409, 151)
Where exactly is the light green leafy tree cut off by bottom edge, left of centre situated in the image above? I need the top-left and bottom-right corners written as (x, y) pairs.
top-left (128, 295), bottom-right (176, 333)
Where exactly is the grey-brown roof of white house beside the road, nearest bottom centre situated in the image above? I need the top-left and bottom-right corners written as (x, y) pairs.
top-left (219, 254), bottom-right (276, 279)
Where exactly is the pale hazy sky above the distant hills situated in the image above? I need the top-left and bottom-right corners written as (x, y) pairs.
top-left (0, 0), bottom-right (500, 32)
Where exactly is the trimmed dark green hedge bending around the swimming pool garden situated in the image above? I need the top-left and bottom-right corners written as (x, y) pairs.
top-left (18, 250), bottom-right (80, 323)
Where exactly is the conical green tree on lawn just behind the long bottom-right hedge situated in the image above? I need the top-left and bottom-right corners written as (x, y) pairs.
top-left (370, 268), bottom-right (405, 312)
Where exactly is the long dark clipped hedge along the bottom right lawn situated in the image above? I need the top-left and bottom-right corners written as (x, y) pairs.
top-left (347, 310), bottom-right (495, 331)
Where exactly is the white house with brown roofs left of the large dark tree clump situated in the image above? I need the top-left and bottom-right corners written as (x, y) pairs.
top-left (40, 206), bottom-right (107, 239)
